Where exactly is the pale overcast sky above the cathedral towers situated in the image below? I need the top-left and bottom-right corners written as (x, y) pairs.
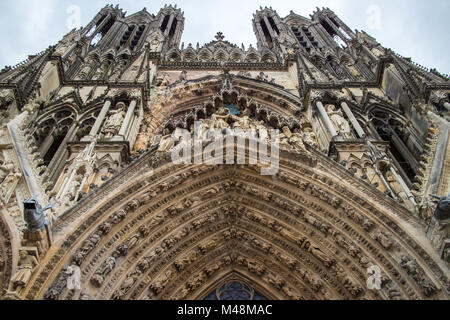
top-left (0, 0), bottom-right (450, 74)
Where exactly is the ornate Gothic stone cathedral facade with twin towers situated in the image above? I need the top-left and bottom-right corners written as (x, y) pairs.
top-left (0, 5), bottom-right (450, 300)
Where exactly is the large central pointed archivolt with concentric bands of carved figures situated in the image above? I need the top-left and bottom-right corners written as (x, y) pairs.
top-left (23, 145), bottom-right (448, 299)
